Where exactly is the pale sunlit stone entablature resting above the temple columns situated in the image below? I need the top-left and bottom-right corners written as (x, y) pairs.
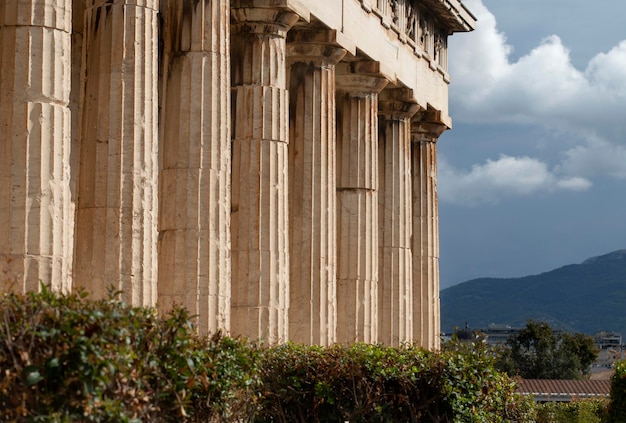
top-left (282, 0), bottom-right (476, 125)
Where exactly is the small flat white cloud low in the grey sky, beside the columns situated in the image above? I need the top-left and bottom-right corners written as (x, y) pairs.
top-left (438, 155), bottom-right (591, 205)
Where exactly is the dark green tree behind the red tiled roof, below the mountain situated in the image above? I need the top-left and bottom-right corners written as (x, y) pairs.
top-left (496, 320), bottom-right (598, 379)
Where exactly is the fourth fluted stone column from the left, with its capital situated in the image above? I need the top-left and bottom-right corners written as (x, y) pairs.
top-left (231, 0), bottom-right (299, 343)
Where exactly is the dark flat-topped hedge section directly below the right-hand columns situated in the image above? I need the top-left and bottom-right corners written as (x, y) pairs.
top-left (257, 343), bottom-right (442, 422)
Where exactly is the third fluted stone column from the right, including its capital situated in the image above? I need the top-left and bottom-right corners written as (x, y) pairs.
top-left (336, 61), bottom-right (387, 343)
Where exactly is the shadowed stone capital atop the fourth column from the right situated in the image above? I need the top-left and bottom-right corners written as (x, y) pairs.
top-left (287, 28), bottom-right (347, 66)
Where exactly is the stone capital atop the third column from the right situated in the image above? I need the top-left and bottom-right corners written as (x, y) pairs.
top-left (335, 60), bottom-right (389, 97)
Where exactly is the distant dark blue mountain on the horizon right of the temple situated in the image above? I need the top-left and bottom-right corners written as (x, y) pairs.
top-left (441, 250), bottom-right (626, 338)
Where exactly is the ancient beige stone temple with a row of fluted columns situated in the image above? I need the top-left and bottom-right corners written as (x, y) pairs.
top-left (0, 0), bottom-right (475, 348)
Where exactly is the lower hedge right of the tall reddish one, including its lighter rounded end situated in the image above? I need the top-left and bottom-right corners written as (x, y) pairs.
top-left (257, 342), bottom-right (533, 423)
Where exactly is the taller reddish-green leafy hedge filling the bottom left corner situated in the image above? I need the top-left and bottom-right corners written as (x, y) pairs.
top-left (0, 286), bottom-right (258, 422)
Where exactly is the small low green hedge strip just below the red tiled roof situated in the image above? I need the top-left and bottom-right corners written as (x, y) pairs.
top-left (536, 399), bottom-right (609, 423)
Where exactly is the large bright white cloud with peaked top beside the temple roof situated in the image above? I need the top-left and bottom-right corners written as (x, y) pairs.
top-left (450, 0), bottom-right (626, 140)
